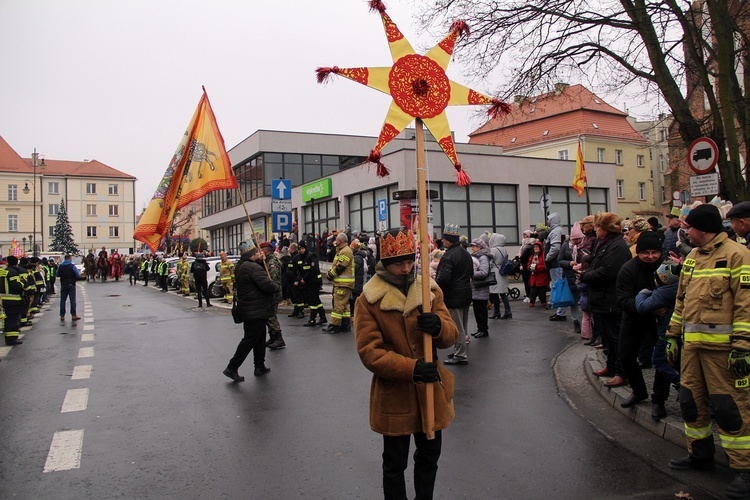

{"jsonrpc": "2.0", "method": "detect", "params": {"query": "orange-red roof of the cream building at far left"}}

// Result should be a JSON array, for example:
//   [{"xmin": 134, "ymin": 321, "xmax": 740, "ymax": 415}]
[{"xmin": 0, "ymin": 136, "xmax": 136, "ymax": 180}]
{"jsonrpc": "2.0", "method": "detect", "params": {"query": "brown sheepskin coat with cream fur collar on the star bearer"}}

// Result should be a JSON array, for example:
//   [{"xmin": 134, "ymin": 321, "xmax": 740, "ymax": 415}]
[{"xmin": 354, "ymin": 272, "xmax": 458, "ymax": 436}]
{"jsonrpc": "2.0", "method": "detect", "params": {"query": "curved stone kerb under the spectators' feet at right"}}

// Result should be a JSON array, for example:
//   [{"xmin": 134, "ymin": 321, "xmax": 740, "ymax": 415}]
[{"xmin": 583, "ymin": 352, "xmax": 729, "ymax": 467}]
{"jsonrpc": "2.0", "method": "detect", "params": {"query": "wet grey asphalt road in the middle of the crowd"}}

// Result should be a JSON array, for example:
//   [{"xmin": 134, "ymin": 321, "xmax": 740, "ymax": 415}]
[{"xmin": 0, "ymin": 282, "xmax": 728, "ymax": 499}]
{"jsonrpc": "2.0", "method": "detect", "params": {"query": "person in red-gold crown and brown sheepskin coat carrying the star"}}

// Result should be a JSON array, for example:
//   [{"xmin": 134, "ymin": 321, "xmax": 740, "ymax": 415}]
[{"xmin": 354, "ymin": 229, "xmax": 458, "ymax": 498}]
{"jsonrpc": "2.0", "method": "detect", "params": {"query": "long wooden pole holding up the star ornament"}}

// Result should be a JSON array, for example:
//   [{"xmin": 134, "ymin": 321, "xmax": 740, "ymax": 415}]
[{"xmin": 415, "ymin": 118, "xmax": 435, "ymax": 439}]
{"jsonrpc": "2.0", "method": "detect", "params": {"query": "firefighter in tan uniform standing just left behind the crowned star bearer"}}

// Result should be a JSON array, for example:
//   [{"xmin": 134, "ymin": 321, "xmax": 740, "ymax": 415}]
[{"xmin": 323, "ymin": 231, "xmax": 354, "ymax": 333}]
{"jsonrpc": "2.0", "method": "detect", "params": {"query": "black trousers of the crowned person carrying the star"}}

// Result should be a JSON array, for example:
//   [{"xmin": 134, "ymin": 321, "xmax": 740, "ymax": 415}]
[{"xmin": 383, "ymin": 431, "xmax": 443, "ymax": 500}]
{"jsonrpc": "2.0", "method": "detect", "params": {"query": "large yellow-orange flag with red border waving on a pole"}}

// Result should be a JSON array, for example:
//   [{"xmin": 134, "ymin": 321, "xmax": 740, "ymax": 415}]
[{"xmin": 133, "ymin": 88, "xmax": 238, "ymax": 252}]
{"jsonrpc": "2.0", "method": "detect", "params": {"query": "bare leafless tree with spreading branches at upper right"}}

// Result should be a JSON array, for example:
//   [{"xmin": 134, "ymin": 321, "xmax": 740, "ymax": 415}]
[{"xmin": 421, "ymin": 0, "xmax": 750, "ymax": 201}]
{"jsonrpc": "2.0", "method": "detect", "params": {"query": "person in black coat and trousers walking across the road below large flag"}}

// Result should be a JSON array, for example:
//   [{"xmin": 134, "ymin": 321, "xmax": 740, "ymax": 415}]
[{"xmin": 224, "ymin": 242, "xmax": 281, "ymax": 382}]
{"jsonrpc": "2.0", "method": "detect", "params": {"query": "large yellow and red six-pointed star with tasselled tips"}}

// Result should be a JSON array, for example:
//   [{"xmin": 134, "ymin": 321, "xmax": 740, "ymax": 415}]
[{"xmin": 316, "ymin": 0, "xmax": 510, "ymax": 186}]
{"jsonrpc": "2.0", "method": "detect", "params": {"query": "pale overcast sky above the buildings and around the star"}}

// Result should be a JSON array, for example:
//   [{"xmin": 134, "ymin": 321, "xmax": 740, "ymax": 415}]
[{"xmin": 0, "ymin": 0, "xmax": 640, "ymax": 213}]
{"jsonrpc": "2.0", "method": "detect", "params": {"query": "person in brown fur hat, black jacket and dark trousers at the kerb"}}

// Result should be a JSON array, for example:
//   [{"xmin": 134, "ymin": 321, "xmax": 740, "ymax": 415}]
[{"xmin": 580, "ymin": 212, "xmax": 632, "ymax": 387}]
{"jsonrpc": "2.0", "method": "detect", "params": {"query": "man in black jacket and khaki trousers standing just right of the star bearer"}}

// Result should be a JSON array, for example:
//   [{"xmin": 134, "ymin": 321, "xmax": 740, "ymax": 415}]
[{"xmin": 435, "ymin": 224, "xmax": 474, "ymax": 365}]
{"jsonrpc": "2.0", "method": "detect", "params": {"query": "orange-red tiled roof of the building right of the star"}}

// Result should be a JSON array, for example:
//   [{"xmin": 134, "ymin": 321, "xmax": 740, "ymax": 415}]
[{"xmin": 469, "ymin": 84, "xmax": 646, "ymax": 152}]
